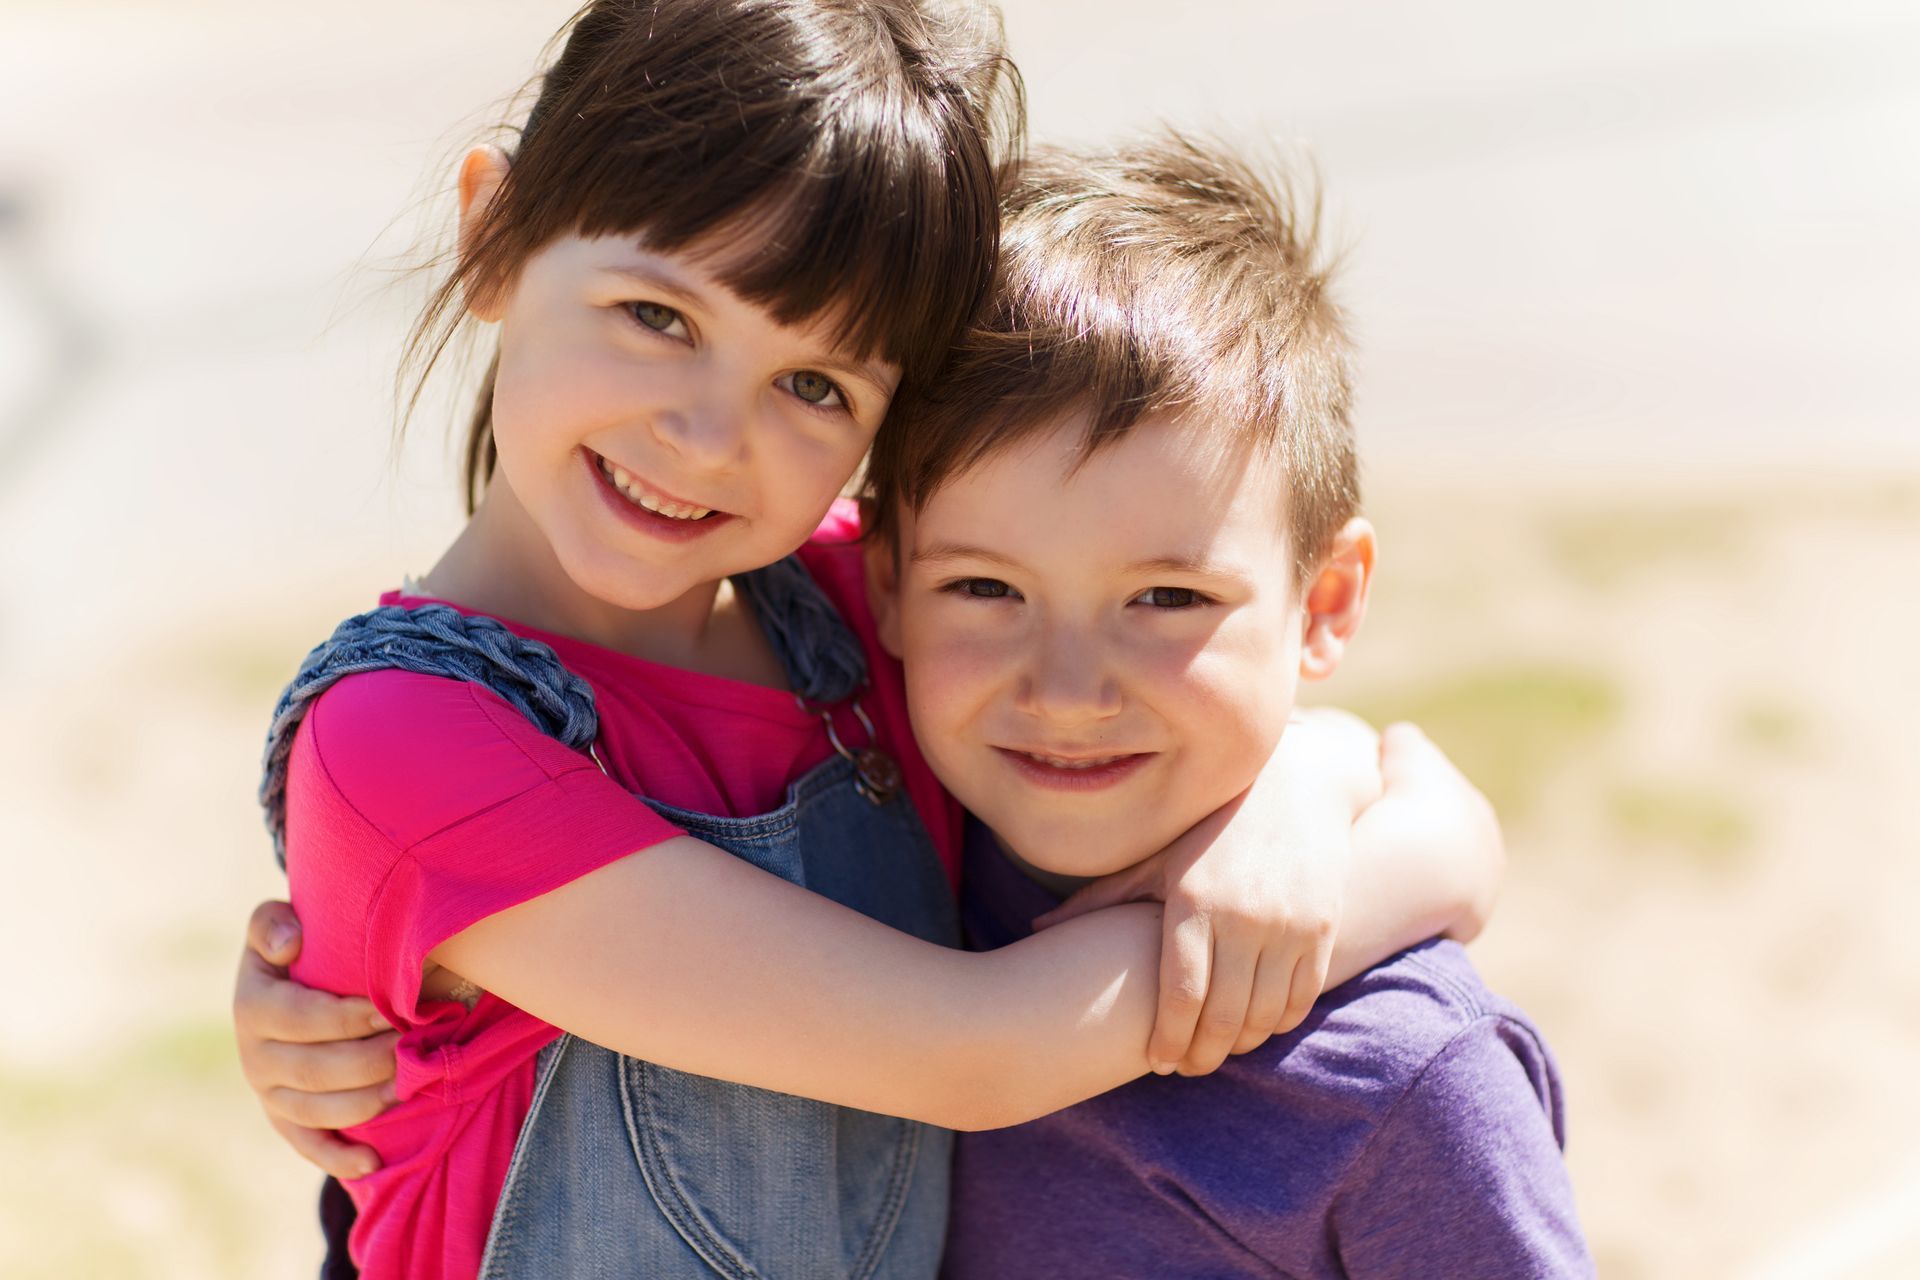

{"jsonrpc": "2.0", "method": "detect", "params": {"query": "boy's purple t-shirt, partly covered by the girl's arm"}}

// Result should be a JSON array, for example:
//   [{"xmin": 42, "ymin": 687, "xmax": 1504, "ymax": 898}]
[{"xmin": 943, "ymin": 823, "xmax": 1594, "ymax": 1280}]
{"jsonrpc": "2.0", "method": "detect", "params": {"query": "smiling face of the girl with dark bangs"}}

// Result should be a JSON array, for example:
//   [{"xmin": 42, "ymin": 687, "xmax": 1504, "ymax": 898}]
[{"xmin": 472, "ymin": 227, "xmax": 899, "ymax": 610}]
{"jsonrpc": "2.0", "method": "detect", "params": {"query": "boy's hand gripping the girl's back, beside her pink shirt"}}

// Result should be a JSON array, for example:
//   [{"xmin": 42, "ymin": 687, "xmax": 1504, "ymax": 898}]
[{"xmin": 234, "ymin": 902, "xmax": 399, "ymax": 1180}]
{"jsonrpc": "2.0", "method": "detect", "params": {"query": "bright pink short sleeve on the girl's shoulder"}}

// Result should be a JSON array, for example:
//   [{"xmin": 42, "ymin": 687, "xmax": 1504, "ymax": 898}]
[{"xmin": 288, "ymin": 672, "xmax": 682, "ymax": 1027}]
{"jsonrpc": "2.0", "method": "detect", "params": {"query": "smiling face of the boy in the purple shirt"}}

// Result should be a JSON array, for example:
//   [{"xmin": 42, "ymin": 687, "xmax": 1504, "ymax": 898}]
[{"xmin": 876, "ymin": 415, "xmax": 1304, "ymax": 875}]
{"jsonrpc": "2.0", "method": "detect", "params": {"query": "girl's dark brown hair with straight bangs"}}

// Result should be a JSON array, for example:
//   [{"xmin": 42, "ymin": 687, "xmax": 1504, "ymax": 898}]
[{"xmin": 405, "ymin": 0, "xmax": 1025, "ymax": 512}]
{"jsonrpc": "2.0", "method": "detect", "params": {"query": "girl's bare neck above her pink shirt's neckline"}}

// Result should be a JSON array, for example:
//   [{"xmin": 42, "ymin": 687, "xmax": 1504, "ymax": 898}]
[{"xmin": 420, "ymin": 482, "xmax": 785, "ymax": 687}]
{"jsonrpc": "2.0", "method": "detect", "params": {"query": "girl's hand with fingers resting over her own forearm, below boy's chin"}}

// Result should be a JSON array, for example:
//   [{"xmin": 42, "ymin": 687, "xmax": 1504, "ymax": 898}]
[{"xmin": 1035, "ymin": 710, "xmax": 1380, "ymax": 1075}]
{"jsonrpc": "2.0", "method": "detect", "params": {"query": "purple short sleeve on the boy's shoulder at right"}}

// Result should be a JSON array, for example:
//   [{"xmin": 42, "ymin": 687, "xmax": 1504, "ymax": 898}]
[{"xmin": 1332, "ymin": 1017, "xmax": 1594, "ymax": 1280}]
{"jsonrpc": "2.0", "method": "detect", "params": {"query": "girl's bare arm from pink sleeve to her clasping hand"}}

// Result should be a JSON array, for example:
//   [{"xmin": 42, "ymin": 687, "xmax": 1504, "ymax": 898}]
[{"xmin": 432, "ymin": 837, "xmax": 1160, "ymax": 1128}]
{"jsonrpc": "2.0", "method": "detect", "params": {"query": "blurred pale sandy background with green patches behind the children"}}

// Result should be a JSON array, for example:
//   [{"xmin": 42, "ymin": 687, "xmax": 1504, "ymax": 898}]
[{"xmin": 0, "ymin": 0, "xmax": 1920, "ymax": 1280}]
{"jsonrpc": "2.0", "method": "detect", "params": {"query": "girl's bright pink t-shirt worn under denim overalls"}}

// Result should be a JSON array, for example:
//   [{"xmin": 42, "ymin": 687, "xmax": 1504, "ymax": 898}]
[{"xmin": 286, "ymin": 503, "xmax": 960, "ymax": 1280}]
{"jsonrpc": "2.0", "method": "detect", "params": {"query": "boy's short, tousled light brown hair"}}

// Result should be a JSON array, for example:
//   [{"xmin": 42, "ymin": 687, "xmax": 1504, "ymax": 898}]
[{"xmin": 868, "ymin": 130, "xmax": 1359, "ymax": 581}]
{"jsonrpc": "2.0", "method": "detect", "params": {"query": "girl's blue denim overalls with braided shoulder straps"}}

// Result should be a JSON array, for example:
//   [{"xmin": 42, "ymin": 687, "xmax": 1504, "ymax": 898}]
[{"xmin": 261, "ymin": 558, "xmax": 960, "ymax": 1280}]
